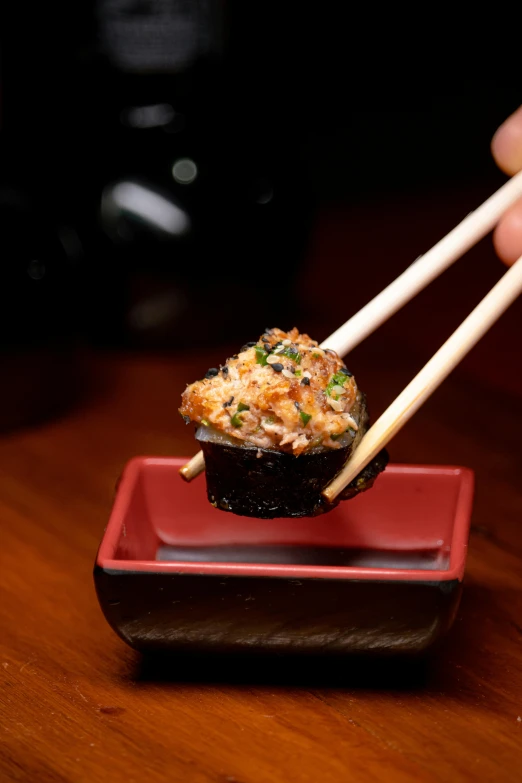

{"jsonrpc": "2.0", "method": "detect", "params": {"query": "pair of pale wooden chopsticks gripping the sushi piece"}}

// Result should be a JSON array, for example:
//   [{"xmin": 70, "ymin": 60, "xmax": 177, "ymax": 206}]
[{"xmin": 180, "ymin": 172, "xmax": 522, "ymax": 501}]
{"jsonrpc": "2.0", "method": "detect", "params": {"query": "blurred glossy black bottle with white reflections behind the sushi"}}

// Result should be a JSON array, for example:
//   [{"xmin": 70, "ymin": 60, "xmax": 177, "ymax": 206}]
[{"xmin": 6, "ymin": 0, "xmax": 312, "ymax": 348}]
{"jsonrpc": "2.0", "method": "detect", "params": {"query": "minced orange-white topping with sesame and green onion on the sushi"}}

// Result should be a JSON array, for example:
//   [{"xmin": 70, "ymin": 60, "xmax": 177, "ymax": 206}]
[{"xmin": 180, "ymin": 328, "xmax": 361, "ymax": 455}]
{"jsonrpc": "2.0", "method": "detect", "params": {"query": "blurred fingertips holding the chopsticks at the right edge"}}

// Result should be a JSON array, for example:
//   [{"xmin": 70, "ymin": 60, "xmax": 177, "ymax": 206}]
[{"xmin": 491, "ymin": 106, "xmax": 522, "ymax": 264}]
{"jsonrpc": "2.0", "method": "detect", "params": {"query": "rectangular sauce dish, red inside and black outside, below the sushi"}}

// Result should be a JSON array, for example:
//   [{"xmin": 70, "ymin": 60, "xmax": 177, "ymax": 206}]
[{"xmin": 94, "ymin": 457, "xmax": 474, "ymax": 654}]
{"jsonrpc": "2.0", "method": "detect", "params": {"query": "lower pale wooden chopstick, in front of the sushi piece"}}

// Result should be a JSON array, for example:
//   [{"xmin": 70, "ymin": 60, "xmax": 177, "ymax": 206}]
[{"xmin": 322, "ymin": 256, "xmax": 522, "ymax": 501}]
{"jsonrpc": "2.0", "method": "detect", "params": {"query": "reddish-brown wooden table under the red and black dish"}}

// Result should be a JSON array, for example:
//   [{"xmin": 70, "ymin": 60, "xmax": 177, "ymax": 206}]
[{"xmin": 0, "ymin": 185, "xmax": 522, "ymax": 783}]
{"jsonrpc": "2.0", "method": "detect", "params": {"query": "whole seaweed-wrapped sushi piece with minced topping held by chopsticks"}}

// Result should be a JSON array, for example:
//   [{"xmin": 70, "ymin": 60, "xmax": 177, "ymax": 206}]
[{"xmin": 179, "ymin": 328, "xmax": 388, "ymax": 519}]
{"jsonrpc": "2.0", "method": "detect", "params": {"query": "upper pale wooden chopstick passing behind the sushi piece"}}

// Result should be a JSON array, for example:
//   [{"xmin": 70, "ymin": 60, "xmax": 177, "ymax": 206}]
[{"xmin": 179, "ymin": 171, "xmax": 522, "ymax": 481}]
